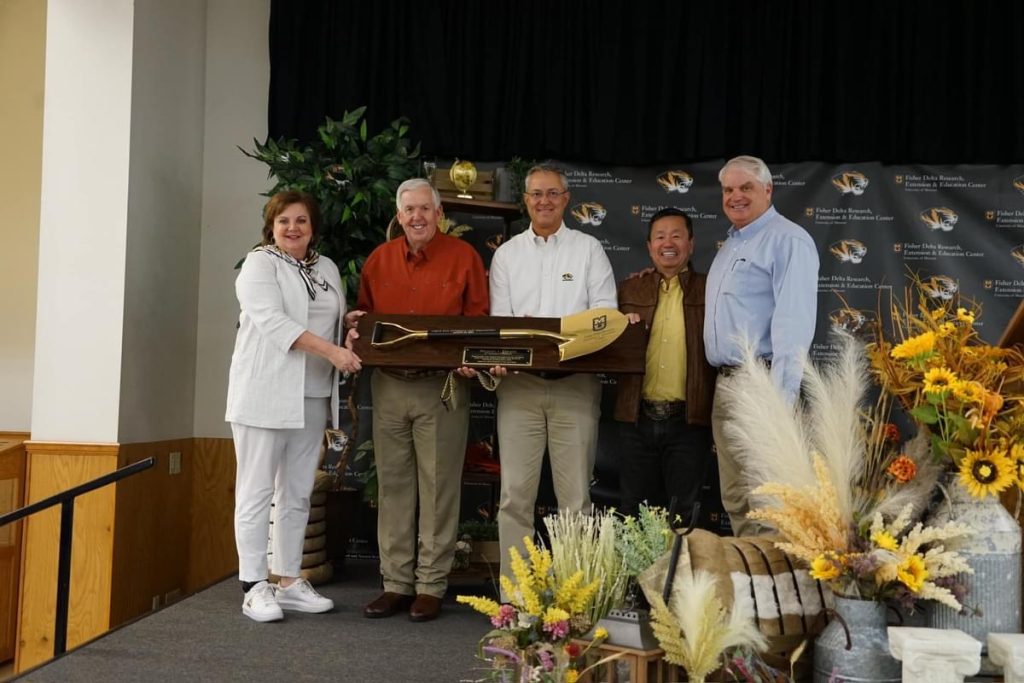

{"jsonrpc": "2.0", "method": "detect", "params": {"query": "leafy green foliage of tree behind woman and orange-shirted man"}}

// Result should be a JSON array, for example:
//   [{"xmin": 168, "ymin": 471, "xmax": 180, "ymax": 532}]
[{"xmin": 239, "ymin": 106, "xmax": 420, "ymax": 302}]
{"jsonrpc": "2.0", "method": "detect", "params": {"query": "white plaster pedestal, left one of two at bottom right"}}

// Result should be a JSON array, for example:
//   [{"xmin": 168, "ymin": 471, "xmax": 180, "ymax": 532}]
[{"xmin": 889, "ymin": 626, "xmax": 981, "ymax": 683}]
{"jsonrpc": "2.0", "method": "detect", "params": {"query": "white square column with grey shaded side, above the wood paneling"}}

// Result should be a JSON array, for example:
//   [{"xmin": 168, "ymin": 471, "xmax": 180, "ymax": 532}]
[{"xmin": 32, "ymin": 0, "xmax": 207, "ymax": 443}]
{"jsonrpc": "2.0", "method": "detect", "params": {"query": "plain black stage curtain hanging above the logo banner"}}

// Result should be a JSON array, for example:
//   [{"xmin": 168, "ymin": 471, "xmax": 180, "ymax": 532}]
[{"xmin": 269, "ymin": 0, "xmax": 1024, "ymax": 166}]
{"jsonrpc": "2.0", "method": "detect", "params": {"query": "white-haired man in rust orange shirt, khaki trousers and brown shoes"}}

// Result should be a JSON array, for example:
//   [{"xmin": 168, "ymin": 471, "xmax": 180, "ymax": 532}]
[{"xmin": 356, "ymin": 178, "xmax": 489, "ymax": 622}]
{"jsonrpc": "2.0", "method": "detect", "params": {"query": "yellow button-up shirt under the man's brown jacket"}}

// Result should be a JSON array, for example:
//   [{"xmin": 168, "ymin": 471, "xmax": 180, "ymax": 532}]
[{"xmin": 643, "ymin": 278, "xmax": 686, "ymax": 400}]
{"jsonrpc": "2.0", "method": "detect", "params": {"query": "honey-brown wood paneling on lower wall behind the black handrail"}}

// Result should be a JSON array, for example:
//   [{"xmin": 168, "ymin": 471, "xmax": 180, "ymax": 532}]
[{"xmin": 14, "ymin": 438, "xmax": 238, "ymax": 671}]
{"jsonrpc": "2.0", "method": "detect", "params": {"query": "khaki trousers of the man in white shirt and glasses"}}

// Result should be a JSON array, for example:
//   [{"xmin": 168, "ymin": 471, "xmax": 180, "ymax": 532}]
[{"xmin": 498, "ymin": 373, "xmax": 601, "ymax": 578}]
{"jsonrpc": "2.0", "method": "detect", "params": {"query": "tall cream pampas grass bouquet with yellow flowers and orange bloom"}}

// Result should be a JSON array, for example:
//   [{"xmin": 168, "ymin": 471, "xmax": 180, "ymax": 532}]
[{"xmin": 720, "ymin": 335, "xmax": 970, "ymax": 609}]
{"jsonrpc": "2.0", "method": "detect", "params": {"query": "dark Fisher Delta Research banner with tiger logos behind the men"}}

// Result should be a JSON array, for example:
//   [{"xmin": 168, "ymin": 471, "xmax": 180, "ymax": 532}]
[{"xmin": 524, "ymin": 161, "xmax": 1024, "ymax": 359}]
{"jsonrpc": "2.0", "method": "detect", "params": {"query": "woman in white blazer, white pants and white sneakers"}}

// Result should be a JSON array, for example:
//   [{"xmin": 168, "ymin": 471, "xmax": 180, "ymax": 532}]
[{"xmin": 225, "ymin": 191, "xmax": 360, "ymax": 622}]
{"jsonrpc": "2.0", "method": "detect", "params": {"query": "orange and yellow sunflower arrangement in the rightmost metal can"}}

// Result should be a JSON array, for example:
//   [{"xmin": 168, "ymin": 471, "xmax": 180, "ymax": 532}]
[{"xmin": 867, "ymin": 281, "xmax": 1024, "ymax": 499}]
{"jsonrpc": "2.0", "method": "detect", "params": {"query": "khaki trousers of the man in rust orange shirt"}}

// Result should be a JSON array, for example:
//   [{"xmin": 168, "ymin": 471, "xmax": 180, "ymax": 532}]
[{"xmin": 371, "ymin": 371, "xmax": 469, "ymax": 598}]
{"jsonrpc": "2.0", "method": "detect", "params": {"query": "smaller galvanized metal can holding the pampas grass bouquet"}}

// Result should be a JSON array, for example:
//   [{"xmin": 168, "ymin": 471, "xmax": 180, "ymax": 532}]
[{"xmin": 814, "ymin": 595, "xmax": 902, "ymax": 683}]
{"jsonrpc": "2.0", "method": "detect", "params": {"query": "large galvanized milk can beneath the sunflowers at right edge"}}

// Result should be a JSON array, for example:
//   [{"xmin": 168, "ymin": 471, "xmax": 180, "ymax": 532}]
[{"xmin": 925, "ymin": 480, "xmax": 1021, "ymax": 673}]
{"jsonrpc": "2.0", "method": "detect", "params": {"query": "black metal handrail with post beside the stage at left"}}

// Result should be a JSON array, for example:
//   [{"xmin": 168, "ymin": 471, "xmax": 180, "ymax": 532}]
[{"xmin": 0, "ymin": 458, "xmax": 157, "ymax": 656}]
